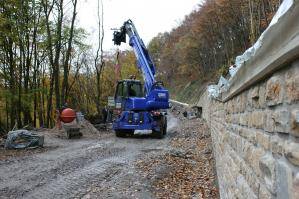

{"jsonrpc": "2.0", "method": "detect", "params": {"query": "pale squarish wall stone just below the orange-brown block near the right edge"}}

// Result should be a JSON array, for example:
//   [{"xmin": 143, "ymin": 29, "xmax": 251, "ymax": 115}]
[{"xmin": 272, "ymin": 109, "xmax": 290, "ymax": 133}]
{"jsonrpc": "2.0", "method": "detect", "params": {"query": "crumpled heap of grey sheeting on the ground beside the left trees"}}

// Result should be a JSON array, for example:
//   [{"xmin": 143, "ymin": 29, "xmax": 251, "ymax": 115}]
[{"xmin": 5, "ymin": 130, "xmax": 44, "ymax": 149}]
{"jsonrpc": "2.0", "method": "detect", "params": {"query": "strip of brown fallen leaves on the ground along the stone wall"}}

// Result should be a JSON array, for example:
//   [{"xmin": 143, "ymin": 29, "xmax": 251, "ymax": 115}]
[{"xmin": 136, "ymin": 119, "xmax": 219, "ymax": 198}]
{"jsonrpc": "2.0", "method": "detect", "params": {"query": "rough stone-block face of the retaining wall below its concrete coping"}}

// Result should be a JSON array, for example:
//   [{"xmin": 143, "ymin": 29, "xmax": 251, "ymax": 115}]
[{"xmin": 198, "ymin": 60, "xmax": 299, "ymax": 198}]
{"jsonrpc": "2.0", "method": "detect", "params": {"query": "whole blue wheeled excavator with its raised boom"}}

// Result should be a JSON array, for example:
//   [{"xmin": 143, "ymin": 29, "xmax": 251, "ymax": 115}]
[{"xmin": 113, "ymin": 20, "xmax": 170, "ymax": 138}]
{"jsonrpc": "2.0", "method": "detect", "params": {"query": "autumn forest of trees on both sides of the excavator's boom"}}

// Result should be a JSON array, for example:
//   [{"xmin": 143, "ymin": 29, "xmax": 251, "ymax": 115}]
[{"xmin": 0, "ymin": 0, "xmax": 281, "ymax": 132}]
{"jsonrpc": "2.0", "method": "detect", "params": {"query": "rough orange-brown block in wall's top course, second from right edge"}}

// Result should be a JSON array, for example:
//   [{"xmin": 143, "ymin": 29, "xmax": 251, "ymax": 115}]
[{"xmin": 266, "ymin": 75, "xmax": 284, "ymax": 106}]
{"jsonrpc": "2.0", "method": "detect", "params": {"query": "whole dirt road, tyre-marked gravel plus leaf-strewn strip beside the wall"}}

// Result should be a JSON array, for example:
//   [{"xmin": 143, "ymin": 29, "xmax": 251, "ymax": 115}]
[{"xmin": 0, "ymin": 112, "xmax": 218, "ymax": 198}]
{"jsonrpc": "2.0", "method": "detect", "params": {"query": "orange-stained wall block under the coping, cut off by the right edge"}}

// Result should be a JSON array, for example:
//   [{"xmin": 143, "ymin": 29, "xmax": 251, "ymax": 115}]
[{"xmin": 285, "ymin": 62, "xmax": 299, "ymax": 103}]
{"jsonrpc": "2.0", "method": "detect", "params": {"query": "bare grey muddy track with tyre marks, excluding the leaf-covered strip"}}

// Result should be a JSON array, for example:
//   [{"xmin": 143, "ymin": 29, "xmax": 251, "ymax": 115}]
[{"xmin": 0, "ymin": 112, "xmax": 218, "ymax": 198}]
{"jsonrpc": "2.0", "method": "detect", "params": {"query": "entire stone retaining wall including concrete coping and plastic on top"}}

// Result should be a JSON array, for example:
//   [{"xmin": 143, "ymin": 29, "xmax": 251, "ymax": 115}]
[{"xmin": 197, "ymin": 0, "xmax": 299, "ymax": 199}]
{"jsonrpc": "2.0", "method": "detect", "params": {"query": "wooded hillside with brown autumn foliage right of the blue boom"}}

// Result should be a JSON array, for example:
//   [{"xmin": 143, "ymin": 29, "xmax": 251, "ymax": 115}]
[{"xmin": 149, "ymin": 0, "xmax": 281, "ymax": 100}]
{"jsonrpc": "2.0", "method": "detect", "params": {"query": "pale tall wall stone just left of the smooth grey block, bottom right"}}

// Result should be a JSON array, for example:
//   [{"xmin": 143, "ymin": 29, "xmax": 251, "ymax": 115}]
[{"xmin": 259, "ymin": 154, "xmax": 276, "ymax": 194}]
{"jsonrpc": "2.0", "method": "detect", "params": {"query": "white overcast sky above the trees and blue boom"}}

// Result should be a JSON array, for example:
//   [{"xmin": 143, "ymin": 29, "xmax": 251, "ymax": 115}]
[{"xmin": 77, "ymin": 0, "xmax": 201, "ymax": 51}]
